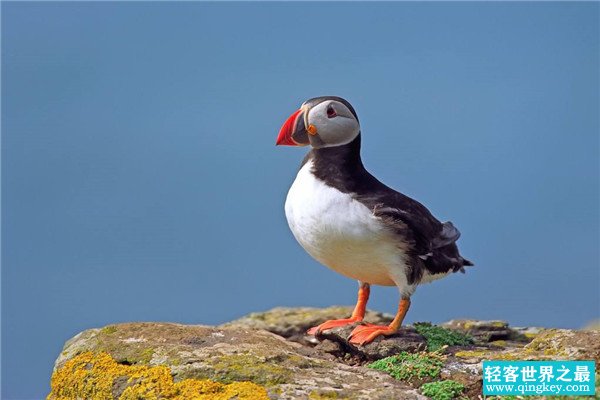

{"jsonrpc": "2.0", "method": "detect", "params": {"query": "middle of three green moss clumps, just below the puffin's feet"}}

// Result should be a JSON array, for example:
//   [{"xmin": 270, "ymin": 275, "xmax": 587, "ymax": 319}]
[{"xmin": 367, "ymin": 351, "xmax": 444, "ymax": 383}]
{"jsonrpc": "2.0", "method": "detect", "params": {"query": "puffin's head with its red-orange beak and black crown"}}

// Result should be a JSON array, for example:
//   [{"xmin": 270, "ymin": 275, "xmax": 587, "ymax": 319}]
[{"xmin": 276, "ymin": 96, "xmax": 360, "ymax": 149}]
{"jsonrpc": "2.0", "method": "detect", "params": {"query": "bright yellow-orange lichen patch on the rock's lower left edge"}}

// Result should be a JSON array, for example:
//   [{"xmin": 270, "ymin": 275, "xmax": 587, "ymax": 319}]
[{"xmin": 47, "ymin": 352, "xmax": 268, "ymax": 400}]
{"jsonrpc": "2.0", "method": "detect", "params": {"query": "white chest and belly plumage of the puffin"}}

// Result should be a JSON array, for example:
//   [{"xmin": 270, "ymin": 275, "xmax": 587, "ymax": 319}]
[{"xmin": 285, "ymin": 161, "xmax": 404, "ymax": 285}]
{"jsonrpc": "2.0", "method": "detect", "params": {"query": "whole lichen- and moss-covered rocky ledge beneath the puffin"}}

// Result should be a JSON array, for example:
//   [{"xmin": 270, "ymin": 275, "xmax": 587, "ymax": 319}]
[{"xmin": 48, "ymin": 307, "xmax": 600, "ymax": 400}]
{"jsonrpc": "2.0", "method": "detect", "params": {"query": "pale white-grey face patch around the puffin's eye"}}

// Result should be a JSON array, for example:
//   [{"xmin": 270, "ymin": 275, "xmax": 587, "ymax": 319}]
[{"xmin": 307, "ymin": 100, "xmax": 360, "ymax": 148}]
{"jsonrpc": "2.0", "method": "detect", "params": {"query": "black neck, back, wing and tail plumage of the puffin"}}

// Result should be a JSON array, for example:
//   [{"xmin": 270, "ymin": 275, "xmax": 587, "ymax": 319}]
[{"xmin": 302, "ymin": 134, "xmax": 473, "ymax": 284}]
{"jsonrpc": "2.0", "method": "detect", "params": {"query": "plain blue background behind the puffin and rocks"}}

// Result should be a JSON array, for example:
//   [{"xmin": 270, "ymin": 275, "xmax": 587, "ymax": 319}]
[{"xmin": 2, "ymin": 2, "xmax": 600, "ymax": 399}]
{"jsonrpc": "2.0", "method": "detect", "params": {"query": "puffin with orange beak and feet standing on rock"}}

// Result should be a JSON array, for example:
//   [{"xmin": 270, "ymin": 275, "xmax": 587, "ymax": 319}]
[{"xmin": 276, "ymin": 96, "xmax": 473, "ymax": 345}]
